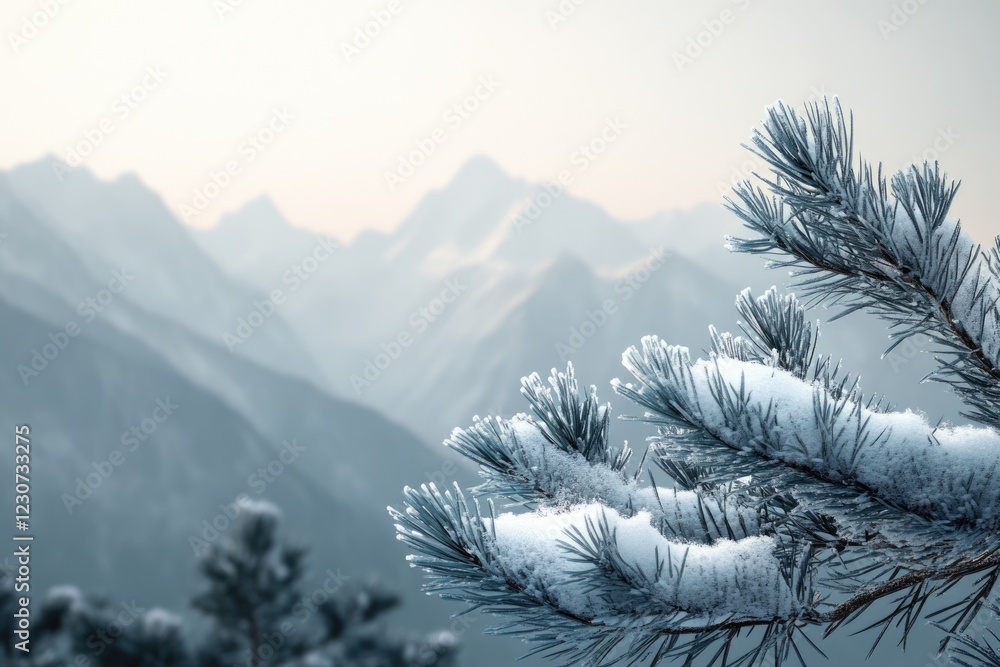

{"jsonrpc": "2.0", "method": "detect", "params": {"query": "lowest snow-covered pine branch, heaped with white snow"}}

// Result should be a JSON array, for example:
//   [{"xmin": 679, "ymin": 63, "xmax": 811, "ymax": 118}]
[{"xmin": 391, "ymin": 484, "xmax": 812, "ymax": 664}]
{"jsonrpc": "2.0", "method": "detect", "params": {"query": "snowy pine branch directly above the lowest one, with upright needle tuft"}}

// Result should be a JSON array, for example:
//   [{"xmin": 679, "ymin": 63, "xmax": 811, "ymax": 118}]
[{"xmin": 445, "ymin": 366, "xmax": 758, "ymax": 543}]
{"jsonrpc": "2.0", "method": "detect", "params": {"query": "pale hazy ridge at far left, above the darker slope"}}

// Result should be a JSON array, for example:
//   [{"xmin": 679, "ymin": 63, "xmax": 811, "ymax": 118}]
[{"xmin": 0, "ymin": 158, "xmax": 323, "ymax": 382}]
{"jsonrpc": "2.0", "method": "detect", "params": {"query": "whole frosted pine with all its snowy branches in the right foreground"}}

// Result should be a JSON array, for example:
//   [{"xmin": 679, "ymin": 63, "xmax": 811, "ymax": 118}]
[{"xmin": 390, "ymin": 100, "xmax": 1000, "ymax": 665}]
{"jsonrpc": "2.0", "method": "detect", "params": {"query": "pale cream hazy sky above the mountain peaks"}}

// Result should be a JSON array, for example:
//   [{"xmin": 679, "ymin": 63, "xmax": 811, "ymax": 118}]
[{"xmin": 0, "ymin": 0, "xmax": 1000, "ymax": 241}]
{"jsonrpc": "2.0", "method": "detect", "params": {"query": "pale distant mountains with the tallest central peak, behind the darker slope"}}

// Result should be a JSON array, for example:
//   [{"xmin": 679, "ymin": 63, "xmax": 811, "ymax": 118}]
[{"xmin": 195, "ymin": 157, "xmax": 958, "ymax": 443}]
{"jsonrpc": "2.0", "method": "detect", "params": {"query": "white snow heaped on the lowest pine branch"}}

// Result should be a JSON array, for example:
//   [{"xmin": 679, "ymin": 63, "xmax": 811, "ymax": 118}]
[{"xmin": 492, "ymin": 503, "xmax": 796, "ymax": 618}]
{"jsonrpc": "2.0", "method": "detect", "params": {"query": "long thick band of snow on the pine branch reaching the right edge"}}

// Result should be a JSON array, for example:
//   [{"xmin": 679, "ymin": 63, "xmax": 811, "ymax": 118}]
[{"xmin": 619, "ymin": 336, "xmax": 1000, "ymax": 530}]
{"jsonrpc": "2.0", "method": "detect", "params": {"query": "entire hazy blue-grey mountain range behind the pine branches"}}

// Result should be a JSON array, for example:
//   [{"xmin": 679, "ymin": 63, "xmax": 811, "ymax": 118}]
[{"xmin": 0, "ymin": 157, "xmax": 957, "ymax": 665}]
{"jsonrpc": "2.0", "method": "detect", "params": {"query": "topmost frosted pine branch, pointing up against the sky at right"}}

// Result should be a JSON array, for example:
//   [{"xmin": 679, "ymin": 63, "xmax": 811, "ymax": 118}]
[{"xmin": 726, "ymin": 99, "xmax": 1000, "ymax": 426}]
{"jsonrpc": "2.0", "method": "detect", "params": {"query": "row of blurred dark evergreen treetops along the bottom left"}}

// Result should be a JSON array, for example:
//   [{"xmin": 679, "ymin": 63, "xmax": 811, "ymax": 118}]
[{"xmin": 0, "ymin": 503, "xmax": 458, "ymax": 667}]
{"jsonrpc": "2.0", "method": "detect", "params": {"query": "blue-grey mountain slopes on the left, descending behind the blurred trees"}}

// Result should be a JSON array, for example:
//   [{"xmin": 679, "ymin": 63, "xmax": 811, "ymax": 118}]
[{"xmin": 0, "ymin": 159, "xmax": 523, "ymax": 664}]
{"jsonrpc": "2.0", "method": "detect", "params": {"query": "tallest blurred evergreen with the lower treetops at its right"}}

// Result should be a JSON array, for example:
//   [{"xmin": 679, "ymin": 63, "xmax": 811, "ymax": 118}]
[{"xmin": 193, "ymin": 503, "xmax": 457, "ymax": 667}]
